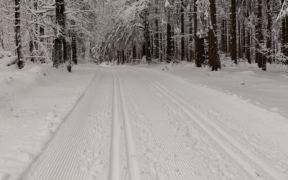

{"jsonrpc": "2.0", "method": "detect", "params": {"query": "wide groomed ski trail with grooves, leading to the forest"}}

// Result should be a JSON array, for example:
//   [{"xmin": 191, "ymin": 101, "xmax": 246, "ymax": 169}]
[{"xmin": 21, "ymin": 67, "xmax": 288, "ymax": 180}]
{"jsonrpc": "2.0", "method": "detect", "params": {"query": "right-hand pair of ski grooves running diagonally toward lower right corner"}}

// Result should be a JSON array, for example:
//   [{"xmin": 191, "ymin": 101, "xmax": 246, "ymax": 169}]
[{"xmin": 138, "ymin": 70, "xmax": 285, "ymax": 180}]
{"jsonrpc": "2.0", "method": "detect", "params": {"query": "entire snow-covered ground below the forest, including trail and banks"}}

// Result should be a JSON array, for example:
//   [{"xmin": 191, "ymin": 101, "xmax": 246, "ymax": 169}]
[{"xmin": 0, "ymin": 59, "xmax": 288, "ymax": 180}]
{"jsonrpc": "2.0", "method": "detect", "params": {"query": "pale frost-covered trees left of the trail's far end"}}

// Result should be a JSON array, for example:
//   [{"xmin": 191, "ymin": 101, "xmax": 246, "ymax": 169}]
[{"xmin": 0, "ymin": 0, "xmax": 99, "ymax": 71}]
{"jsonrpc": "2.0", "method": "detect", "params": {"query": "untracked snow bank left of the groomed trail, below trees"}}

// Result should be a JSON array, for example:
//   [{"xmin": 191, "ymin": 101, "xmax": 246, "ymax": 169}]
[{"xmin": 0, "ymin": 61, "xmax": 95, "ymax": 180}]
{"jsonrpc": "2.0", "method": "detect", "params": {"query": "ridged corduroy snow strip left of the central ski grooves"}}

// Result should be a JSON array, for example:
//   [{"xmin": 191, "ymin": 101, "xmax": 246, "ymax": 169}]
[{"xmin": 21, "ymin": 70, "xmax": 112, "ymax": 180}]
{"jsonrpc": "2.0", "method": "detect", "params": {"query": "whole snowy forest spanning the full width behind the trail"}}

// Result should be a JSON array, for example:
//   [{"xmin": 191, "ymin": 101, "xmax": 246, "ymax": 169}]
[{"xmin": 0, "ymin": 0, "xmax": 288, "ymax": 71}]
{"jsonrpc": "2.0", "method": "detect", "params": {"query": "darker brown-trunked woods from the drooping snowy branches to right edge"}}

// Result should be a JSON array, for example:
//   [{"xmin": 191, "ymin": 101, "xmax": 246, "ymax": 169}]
[{"xmin": 96, "ymin": 0, "xmax": 288, "ymax": 71}]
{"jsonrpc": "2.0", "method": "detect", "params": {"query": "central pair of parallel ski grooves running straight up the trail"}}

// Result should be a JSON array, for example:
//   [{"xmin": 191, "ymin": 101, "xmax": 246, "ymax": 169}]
[{"xmin": 109, "ymin": 71, "xmax": 140, "ymax": 180}]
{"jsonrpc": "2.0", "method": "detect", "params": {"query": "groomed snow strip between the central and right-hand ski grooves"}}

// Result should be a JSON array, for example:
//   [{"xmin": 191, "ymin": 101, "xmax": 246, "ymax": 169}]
[{"xmin": 118, "ymin": 69, "xmax": 251, "ymax": 180}]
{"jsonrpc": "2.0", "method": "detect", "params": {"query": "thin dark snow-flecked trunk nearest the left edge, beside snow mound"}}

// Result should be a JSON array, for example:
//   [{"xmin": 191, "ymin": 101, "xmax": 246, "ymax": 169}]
[{"xmin": 15, "ymin": 0, "xmax": 25, "ymax": 69}]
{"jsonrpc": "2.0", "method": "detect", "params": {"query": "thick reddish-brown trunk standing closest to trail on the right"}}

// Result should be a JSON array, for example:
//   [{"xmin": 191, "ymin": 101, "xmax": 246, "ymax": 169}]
[{"xmin": 208, "ymin": 0, "xmax": 221, "ymax": 71}]
